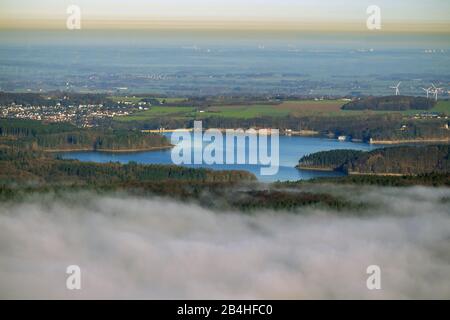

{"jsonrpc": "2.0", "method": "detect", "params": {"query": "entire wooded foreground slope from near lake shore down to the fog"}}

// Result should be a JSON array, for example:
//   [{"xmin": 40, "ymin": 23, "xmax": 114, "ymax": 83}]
[{"xmin": 0, "ymin": 147, "xmax": 360, "ymax": 212}]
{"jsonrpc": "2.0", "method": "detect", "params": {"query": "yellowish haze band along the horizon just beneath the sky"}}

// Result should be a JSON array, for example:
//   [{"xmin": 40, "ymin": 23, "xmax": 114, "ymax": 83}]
[{"xmin": 0, "ymin": 19, "xmax": 450, "ymax": 34}]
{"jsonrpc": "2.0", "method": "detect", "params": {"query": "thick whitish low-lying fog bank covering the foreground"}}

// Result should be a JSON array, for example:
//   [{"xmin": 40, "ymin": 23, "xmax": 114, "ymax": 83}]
[{"xmin": 0, "ymin": 188, "xmax": 450, "ymax": 299}]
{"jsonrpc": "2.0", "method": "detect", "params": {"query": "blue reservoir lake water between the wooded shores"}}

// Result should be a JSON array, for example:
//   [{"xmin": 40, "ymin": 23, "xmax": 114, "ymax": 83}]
[{"xmin": 61, "ymin": 136, "xmax": 384, "ymax": 182}]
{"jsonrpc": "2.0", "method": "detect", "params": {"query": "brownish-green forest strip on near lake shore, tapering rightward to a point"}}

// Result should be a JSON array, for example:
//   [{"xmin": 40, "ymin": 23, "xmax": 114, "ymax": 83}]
[{"xmin": 0, "ymin": 146, "xmax": 255, "ymax": 185}]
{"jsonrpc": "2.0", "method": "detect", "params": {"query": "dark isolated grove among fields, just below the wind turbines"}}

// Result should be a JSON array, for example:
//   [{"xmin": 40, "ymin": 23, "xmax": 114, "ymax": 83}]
[{"xmin": 342, "ymin": 96, "xmax": 436, "ymax": 111}]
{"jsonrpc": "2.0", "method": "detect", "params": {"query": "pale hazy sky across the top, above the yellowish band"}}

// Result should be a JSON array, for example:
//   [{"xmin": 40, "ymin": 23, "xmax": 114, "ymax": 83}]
[{"xmin": 0, "ymin": 0, "xmax": 450, "ymax": 29}]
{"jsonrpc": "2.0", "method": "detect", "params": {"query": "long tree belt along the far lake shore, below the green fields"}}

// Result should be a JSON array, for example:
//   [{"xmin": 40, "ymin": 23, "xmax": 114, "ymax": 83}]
[{"xmin": 109, "ymin": 113, "xmax": 450, "ymax": 142}]
